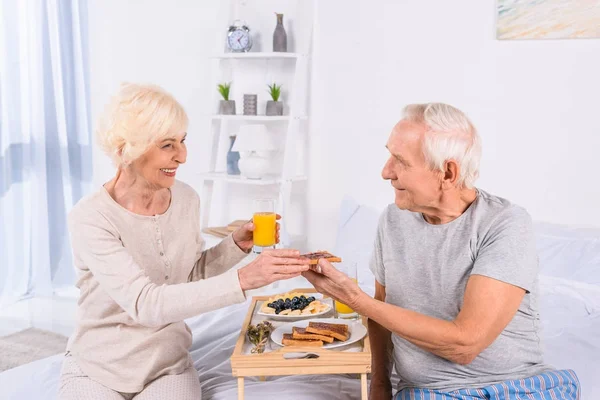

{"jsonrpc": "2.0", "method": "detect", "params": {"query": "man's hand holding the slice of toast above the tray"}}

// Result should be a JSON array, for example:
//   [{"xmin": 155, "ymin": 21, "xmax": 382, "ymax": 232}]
[{"xmin": 302, "ymin": 259, "xmax": 367, "ymax": 310}]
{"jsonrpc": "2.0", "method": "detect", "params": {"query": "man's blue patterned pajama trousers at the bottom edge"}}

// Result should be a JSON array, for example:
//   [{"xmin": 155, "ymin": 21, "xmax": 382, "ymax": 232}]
[{"xmin": 395, "ymin": 369, "xmax": 581, "ymax": 400}]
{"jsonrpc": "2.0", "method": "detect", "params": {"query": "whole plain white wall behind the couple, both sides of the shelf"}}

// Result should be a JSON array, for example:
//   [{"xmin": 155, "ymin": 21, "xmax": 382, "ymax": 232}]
[{"xmin": 90, "ymin": 0, "xmax": 600, "ymax": 253}]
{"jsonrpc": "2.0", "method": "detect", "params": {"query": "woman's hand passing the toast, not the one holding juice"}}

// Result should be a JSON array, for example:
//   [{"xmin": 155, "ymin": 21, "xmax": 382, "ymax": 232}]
[{"xmin": 238, "ymin": 249, "xmax": 310, "ymax": 290}]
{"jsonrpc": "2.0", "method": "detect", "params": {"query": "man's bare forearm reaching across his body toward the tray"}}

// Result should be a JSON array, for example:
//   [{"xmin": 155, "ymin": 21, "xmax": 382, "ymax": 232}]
[{"xmin": 354, "ymin": 295, "xmax": 473, "ymax": 364}]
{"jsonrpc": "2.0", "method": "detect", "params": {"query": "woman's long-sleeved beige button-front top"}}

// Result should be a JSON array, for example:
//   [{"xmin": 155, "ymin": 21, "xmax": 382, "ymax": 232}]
[{"xmin": 67, "ymin": 181, "xmax": 246, "ymax": 393}]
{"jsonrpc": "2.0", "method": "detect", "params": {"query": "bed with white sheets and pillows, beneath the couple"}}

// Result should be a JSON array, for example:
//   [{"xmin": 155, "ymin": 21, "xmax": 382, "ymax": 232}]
[{"xmin": 0, "ymin": 198, "xmax": 600, "ymax": 400}]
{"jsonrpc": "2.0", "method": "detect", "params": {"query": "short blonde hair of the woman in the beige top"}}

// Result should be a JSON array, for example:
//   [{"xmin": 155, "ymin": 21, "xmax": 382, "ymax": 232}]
[{"xmin": 96, "ymin": 83, "xmax": 188, "ymax": 166}]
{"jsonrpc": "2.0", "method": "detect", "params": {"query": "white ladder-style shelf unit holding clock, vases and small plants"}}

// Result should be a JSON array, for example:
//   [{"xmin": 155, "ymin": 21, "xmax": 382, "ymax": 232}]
[{"xmin": 198, "ymin": 0, "xmax": 316, "ymax": 247}]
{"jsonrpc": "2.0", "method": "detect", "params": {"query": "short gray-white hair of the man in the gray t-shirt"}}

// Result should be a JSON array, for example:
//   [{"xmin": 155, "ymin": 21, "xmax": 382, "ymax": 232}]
[{"xmin": 403, "ymin": 103, "xmax": 481, "ymax": 189}]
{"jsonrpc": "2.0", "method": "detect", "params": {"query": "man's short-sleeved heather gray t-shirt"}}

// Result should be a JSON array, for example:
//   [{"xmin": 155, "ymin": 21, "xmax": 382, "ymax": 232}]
[{"xmin": 371, "ymin": 189, "xmax": 548, "ymax": 390}]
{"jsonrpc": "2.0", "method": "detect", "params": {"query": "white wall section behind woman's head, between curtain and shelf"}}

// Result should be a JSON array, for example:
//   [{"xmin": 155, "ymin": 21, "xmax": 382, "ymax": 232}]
[{"xmin": 89, "ymin": 0, "xmax": 218, "ymax": 186}]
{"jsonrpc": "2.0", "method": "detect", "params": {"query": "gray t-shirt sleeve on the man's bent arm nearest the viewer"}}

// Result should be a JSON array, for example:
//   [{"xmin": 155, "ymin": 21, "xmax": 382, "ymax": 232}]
[{"xmin": 471, "ymin": 206, "xmax": 539, "ymax": 292}]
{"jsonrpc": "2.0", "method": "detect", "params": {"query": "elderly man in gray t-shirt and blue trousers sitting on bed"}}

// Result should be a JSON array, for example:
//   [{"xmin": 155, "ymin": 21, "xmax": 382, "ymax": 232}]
[{"xmin": 304, "ymin": 104, "xmax": 580, "ymax": 400}]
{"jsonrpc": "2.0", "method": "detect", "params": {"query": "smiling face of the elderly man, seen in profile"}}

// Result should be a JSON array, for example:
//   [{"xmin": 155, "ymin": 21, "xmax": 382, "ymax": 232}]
[{"xmin": 381, "ymin": 120, "xmax": 443, "ymax": 211}]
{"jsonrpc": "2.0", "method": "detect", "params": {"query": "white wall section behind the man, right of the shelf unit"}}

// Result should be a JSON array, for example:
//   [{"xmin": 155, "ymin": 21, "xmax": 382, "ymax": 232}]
[{"xmin": 309, "ymin": 0, "xmax": 600, "ymax": 247}]
